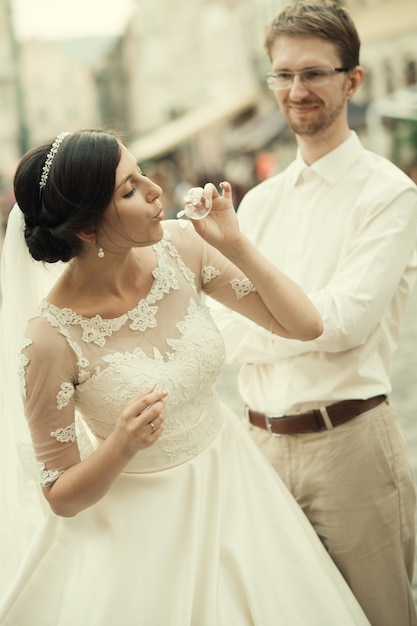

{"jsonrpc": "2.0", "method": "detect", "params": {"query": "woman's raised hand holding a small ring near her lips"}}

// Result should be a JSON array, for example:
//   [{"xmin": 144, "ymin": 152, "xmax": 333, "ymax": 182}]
[{"xmin": 188, "ymin": 182, "xmax": 241, "ymax": 251}]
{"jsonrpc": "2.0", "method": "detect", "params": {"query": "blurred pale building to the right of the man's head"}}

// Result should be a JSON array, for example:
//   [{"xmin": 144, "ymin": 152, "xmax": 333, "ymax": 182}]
[{"xmin": 346, "ymin": 0, "xmax": 417, "ymax": 176}]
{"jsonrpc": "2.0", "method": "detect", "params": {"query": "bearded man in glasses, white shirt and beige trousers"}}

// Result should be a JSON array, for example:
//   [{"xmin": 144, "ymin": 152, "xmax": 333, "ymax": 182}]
[{"xmin": 214, "ymin": 0, "xmax": 417, "ymax": 626}]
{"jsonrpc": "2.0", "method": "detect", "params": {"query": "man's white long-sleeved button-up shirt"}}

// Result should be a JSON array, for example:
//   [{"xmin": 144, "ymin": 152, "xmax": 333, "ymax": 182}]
[{"xmin": 212, "ymin": 132, "xmax": 417, "ymax": 415}]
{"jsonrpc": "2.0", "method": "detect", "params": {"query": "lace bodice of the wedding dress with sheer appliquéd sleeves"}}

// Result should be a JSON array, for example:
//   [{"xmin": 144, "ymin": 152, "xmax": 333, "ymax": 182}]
[{"xmin": 21, "ymin": 222, "xmax": 266, "ymax": 484}]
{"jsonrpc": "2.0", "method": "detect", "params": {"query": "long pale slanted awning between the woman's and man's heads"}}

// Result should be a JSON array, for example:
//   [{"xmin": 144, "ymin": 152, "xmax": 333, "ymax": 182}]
[{"xmin": 129, "ymin": 90, "xmax": 258, "ymax": 161}]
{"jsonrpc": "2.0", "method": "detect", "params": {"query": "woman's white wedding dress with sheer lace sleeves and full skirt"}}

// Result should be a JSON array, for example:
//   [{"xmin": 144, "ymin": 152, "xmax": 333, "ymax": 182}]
[{"xmin": 0, "ymin": 222, "xmax": 368, "ymax": 626}]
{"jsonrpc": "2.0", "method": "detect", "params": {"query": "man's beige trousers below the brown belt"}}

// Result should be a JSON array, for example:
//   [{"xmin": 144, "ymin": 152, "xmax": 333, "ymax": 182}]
[{"xmin": 249, "ymin": 402, "xmax": 417, "ymax": 626}]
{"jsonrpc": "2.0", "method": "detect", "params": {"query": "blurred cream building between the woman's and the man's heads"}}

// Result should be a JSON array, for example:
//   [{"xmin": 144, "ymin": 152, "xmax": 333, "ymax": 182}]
[{"xmin": 105, "ymin": 0, "xmax": 258, "ymax": 179}]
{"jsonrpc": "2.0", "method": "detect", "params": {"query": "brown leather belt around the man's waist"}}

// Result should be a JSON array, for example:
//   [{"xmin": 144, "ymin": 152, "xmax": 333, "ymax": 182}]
[{"xmin": 247, "ymin": 396, "xmax": 386, "ymax": 435}]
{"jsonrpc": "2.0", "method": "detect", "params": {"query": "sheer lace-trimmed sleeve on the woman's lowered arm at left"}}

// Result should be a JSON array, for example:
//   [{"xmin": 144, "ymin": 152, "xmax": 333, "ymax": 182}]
[{"xmin": 20, "ymin": 318, "xmax": 80, "ymax": 486}]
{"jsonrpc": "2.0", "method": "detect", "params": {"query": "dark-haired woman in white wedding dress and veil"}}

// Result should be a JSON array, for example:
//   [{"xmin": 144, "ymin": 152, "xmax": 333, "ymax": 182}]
[{"xmin": 0, "ymin": 130, "xmax": 368, "ymax": 626}]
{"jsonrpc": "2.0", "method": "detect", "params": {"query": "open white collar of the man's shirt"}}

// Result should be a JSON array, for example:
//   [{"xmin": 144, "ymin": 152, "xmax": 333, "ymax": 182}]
[{"xmin": 293, "ymin": 131, "xmax": 363, "ymax": 187}]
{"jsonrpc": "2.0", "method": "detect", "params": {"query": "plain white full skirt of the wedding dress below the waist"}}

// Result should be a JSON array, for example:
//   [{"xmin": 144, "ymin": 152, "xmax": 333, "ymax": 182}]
[{"xmin": 0, "ymin": 405, "xmax": 369, "ymax": 626}]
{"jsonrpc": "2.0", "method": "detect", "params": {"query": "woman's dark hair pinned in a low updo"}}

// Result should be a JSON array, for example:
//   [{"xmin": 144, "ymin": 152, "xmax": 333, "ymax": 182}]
[{"xmin": 14, "ymin": 130, "xmax": 123, "ymax": 263}]
